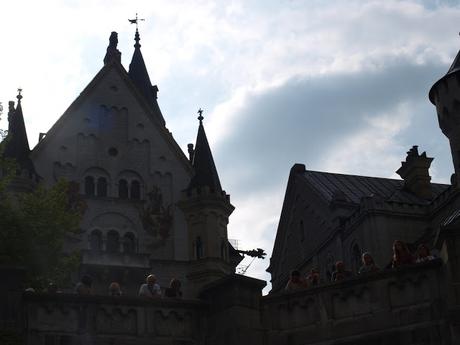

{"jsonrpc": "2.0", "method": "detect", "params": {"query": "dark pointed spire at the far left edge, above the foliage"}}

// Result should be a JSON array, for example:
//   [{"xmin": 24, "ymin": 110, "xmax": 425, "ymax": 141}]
[{"xmin": 3, "ymin": 89, "xmax": 38, "ymax": 178}]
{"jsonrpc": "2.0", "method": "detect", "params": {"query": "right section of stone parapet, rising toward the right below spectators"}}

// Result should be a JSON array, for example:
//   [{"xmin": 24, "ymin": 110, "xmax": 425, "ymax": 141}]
[{"xmin": 261, "ymin": 260, "xmax": 448, "ymax": 344}]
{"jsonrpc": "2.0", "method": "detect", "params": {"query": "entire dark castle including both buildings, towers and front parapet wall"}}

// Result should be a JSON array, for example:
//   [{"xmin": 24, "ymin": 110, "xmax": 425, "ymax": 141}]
[{"xmin": 0, "ymin": 31, "xmax": 460, "ymax": 345}]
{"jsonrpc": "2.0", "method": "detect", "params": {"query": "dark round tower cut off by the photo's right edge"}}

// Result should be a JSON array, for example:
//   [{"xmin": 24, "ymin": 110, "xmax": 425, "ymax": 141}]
[{"xmin": 429, "ymin": 42, "xmax": 460, "ymax": 184}]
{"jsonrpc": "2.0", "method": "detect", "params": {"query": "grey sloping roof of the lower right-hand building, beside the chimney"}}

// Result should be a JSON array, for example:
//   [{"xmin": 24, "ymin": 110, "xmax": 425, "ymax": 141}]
[{"xmin": 303, "ymin": 170, "xmax": 449, "ymax": 205}]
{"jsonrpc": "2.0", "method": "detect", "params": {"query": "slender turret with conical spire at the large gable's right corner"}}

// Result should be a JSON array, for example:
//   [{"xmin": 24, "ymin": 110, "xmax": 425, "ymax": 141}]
[{"xmin": 179, "ymin": 109, "xmax": 235, "ymax": 291}]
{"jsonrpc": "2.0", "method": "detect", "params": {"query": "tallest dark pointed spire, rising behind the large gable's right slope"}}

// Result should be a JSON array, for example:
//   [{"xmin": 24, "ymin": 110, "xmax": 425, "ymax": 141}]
[{"xmin": 128, "ymin": 29, "xmax": 165, "ymax": 125}]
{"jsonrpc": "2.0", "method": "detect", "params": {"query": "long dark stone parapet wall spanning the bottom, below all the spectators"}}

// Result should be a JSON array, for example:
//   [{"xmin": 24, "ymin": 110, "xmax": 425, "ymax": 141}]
[{"xmin": 4, "ymin": 259, "xmax": 460, "ymax": 345}]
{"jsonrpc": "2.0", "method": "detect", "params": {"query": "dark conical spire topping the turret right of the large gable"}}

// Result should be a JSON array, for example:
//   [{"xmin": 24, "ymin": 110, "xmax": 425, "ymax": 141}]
[{"xmin": 188, "ymin": 108, "xmax": 222, "ymax": 193}]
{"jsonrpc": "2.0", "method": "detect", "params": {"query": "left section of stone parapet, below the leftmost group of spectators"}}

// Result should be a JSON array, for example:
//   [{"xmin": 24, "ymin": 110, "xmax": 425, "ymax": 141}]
[{"xmin": 23, "ymin": 293, "xmax": 207, "ymax": 345}]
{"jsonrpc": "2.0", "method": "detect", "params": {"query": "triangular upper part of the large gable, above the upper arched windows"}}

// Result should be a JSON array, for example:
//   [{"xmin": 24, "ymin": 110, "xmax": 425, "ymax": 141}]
[{"xmin": 32, "ymin": 61, "xmax": 192, "ymax": 188}]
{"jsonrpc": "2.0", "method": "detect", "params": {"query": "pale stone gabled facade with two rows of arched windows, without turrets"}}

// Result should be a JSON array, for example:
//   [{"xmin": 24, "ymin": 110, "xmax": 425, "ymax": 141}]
[{"xmin": 31, "ymin": 59, "xmax": 193, "ymax": 266}]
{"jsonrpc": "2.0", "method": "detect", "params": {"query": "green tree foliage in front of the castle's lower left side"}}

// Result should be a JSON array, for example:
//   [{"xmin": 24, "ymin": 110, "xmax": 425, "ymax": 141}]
[{"xmin": 0, "ymin": 173, "xmax": 84, "ymax": 289}]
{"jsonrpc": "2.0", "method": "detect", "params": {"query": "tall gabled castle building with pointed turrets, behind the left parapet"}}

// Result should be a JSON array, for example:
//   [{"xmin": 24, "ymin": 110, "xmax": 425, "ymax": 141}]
[{"xmin": 0, "ymin": 29, "xmax": 241, "ymax": 297}]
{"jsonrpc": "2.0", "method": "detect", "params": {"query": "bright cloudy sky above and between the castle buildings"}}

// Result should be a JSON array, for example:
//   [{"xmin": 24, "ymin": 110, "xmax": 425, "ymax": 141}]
[{"xmin": 0, "ymin": 0, "xmax": 460, "ymax": 292}]
